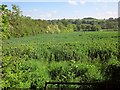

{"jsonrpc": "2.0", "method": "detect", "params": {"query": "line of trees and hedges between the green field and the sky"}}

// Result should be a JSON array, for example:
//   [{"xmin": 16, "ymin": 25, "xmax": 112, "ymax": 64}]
[{"xmin": 0, "ymin": 5, "xmax": 118, "ymax": 38}]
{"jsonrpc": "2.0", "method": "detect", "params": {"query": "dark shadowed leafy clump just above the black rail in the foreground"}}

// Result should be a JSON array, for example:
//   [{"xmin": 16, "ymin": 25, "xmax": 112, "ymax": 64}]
[{"xmin": 49, "ymin": 60, "xmax": 103, "ymax": 82}]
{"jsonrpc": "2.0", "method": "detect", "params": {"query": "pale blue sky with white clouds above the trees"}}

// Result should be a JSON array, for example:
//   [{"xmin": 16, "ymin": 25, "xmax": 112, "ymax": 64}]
[{"xmin": 2, "ymin": 0, "xmax": 119, "ymax": 20}]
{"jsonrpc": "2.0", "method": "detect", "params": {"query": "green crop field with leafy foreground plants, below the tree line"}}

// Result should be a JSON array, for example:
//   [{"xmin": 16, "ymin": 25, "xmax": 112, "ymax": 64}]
[{"xmin": 2, "ymin": 31, "xmax": 120, "ymax": 88}]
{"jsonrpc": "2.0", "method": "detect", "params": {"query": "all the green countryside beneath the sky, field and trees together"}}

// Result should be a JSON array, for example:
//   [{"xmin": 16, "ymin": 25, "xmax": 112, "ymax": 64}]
[{"xmin": 0, "ymin": 4, "xmax": 120, "ymax": 90}]
